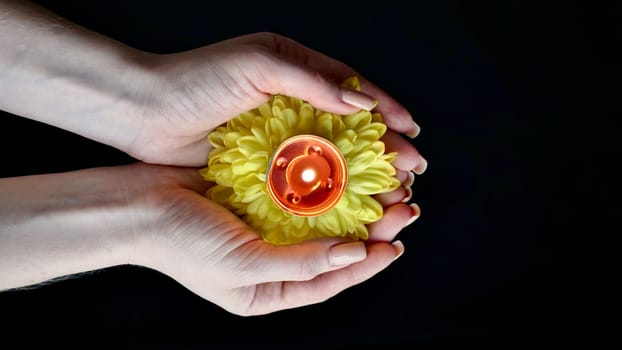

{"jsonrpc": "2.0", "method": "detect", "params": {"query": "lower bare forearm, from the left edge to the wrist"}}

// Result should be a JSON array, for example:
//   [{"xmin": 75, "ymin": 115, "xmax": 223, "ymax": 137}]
[{"xmin": 0, "ymin": 168, "xmax": 134, "ymax": 290}]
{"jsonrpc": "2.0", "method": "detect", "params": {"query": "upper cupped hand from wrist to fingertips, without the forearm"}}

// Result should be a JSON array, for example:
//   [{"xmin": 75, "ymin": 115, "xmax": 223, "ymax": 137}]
[{"xmin": 126, "ymin": 33, "xmax": 426, "ymax": 172}]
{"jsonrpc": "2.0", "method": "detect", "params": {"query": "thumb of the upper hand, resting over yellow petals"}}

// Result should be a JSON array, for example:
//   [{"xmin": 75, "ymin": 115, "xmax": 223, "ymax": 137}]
[{"xmin": 250, "ymin": 54, "xmax": 378, "ymax": 115}]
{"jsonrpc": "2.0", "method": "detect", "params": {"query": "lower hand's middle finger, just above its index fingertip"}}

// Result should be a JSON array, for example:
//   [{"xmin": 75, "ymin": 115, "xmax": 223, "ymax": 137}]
[{"xmin": 367, "ymin": 203, "xmax": 421, "ymax": 241}]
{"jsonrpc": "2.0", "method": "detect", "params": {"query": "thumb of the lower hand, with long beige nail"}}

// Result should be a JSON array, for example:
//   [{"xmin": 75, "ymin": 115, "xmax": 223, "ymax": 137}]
[{"xmin": 256, "ymin": 239, "xmax": 367, "ymax": 282}]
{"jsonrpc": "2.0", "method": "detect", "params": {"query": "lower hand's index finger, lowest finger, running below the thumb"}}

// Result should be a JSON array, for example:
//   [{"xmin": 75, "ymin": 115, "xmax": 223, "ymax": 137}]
[{"xmin": 249, "ymin": 242, "xmax": 404, "ymax": 314}]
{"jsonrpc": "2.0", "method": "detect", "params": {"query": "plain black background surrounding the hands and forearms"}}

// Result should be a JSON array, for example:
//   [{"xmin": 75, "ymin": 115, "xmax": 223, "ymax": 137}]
[{"xmin": 0, "ymin": 0, "xmax": 622, "ymax": 349}]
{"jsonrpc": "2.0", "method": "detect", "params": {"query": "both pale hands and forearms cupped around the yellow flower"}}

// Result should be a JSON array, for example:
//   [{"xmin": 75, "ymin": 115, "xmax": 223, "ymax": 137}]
[{"xmin": 0, "ymin": 1, "xmax": 427, "ymax": 315}]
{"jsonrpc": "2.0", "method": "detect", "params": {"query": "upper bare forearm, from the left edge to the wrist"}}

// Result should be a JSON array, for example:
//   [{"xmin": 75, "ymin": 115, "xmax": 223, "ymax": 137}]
[{"xmin": 0, "ymin": 1, "xmax": 151, "ymax": 150}]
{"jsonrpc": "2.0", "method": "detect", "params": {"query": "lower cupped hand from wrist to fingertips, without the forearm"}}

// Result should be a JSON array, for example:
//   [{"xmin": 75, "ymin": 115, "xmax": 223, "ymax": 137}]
[{"xmin": 123, "ymin": 163, "xmax": 413, "ymax": 315}]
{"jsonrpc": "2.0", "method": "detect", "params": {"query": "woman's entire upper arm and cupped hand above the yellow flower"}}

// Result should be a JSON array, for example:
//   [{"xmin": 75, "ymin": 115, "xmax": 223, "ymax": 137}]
[{"xmin": 0, "ymin": 1, "xmax": 427, "ymax": 174}]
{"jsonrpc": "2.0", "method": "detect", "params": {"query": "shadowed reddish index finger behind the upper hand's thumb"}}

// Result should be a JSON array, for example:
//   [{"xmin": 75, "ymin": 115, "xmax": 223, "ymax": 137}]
[{"xmin": 229, "ymin": 33, "xmax": 421, "ymax": 137}]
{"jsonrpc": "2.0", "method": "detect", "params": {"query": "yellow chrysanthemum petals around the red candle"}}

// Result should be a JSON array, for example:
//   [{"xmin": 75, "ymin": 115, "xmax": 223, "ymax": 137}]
[{"xmin": 200, "ymin": 77, "xmax": 400, "ymax": 245}]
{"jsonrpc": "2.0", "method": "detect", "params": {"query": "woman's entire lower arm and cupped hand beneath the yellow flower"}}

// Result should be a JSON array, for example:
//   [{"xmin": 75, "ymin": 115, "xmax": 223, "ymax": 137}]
[{"xmin": 0, "ymin": 163, "xmax": 412, "ymax": 315}]
